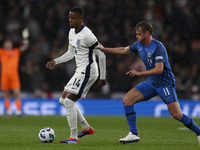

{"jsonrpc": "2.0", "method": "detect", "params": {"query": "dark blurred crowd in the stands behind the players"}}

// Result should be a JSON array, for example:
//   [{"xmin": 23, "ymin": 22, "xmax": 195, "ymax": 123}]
[{"xmin": 0, "ymin": 0, "xmax": 200, "ymax": 100}]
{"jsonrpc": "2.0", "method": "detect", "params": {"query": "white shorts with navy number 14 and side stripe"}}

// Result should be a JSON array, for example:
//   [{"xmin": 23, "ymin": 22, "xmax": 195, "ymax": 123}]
[{"xmin": 64, "ymin": 73, "xmax": 98, "ymax": 98}]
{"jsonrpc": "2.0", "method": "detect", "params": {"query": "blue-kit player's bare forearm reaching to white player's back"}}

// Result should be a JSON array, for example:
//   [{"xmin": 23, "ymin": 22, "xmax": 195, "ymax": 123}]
[{"xmin": 96, "ymin": 43, "xmax": 130, "ymax": 55}]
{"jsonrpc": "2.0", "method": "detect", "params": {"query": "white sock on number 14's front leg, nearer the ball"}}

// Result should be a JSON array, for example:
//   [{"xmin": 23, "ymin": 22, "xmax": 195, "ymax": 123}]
[{"xmin": 64, "ymin": 98, "xmax": 78, "ymax": 139}]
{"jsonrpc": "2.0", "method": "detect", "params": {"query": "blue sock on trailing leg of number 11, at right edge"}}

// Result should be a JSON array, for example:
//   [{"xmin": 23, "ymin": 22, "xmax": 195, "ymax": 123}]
[{"xmin": 180, "ymin": 114, "xmax": 200, "ymax": 136}]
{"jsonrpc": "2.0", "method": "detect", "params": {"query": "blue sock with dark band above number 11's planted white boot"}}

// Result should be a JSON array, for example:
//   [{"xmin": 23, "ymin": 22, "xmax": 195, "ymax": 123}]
[{"xmin": 124, "ymin": 105, "xmax": 138, "ymax": 135}]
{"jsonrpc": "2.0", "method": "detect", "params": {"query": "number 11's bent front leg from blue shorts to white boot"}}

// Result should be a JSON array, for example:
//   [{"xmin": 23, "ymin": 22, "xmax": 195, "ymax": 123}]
[{"xmin": 119, "ymin": 81, "xmax": 157, "ymax": 143}]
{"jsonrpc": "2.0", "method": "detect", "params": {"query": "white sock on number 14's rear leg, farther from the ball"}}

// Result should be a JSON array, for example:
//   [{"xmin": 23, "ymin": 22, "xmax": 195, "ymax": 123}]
[{"xmin": 74, "ymin": 105, "xmax": 90, "ymax": 130}]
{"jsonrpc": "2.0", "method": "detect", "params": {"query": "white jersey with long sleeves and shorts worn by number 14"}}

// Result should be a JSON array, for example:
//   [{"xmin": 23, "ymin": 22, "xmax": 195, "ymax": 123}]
[{"xmin": 54, "ymin": 24, "xmax": 106, "ymax": 97}]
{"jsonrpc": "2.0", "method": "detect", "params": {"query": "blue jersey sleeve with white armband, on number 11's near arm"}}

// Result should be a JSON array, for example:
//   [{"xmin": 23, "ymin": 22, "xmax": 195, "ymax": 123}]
[{"xmin": 155, "ymin": 45, "xmax": 165, "ymax": 63}]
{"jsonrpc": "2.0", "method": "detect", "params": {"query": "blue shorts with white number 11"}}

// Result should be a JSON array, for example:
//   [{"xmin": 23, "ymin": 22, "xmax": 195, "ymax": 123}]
[{"xmin": 135, "ymin": 81, "xmax": 178, "ymax": 104}]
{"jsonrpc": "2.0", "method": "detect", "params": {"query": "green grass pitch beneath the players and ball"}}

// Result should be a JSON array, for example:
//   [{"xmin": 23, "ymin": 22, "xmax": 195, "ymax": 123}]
[{"xmin": 0, "ymin": 116, "xmax": 200, "ymax": 150}]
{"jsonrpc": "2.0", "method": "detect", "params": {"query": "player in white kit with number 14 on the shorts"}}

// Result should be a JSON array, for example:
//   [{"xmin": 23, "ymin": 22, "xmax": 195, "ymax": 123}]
[{"xmin": 46, "ymin": 6, "xmax": 106, "ymax": 143}]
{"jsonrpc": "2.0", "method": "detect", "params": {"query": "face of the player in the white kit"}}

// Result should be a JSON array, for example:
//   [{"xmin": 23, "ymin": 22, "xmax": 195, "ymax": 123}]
[{"xmin": 69, "ymin": 12, "xmax": 83, "ymax": 28}]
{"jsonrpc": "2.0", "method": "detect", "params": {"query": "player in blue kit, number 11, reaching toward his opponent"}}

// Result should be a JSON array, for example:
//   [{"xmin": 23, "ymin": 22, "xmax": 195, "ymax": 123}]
[{"xmin": 96, "ymin": 21, "xmax": 200, "ymax": 143}]
